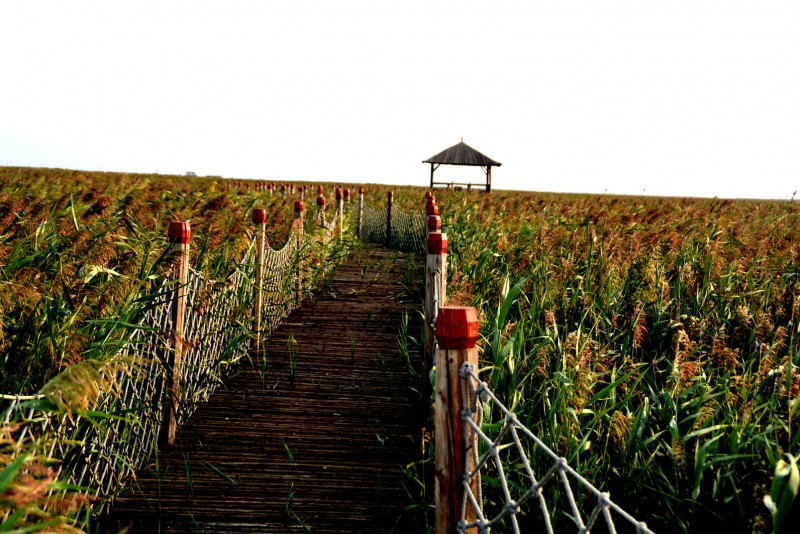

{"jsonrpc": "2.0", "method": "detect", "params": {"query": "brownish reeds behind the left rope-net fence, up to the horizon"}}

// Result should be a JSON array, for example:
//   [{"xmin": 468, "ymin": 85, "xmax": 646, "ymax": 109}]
[{"xmin": 0, "ymin": 167, "xmax": 302, "ymax": 394}]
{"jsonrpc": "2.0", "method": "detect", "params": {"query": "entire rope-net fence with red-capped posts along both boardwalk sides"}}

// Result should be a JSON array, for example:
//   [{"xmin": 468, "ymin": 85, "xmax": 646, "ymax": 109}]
[{"xmin": 0, "ymin": 185, "xmax": 651, "ymax": 534}]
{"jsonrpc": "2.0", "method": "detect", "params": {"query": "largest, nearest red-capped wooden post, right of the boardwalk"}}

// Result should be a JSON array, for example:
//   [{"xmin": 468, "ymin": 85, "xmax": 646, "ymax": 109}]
[{"xmin": 431, "ymin": 308, "xmax": 478, "ymax": 534}]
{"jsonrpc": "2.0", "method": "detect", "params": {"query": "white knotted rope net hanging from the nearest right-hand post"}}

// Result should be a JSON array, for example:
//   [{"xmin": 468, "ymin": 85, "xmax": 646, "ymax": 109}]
[{"xmin": 458, "ymin": 362, "xmax": 652, "ymax": 533}]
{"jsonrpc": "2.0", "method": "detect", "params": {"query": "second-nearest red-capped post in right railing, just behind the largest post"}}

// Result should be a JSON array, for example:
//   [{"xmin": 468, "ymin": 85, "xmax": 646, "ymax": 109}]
[{"xmin": 422, "ymin": 232, "xmax": 447, "ymax": 398}]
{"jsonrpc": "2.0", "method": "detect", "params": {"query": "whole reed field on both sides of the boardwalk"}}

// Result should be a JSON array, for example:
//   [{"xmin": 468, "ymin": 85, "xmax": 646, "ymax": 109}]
[{"xmin": 0, "ymin": 167, "xmax": 800, "ymax": 532}]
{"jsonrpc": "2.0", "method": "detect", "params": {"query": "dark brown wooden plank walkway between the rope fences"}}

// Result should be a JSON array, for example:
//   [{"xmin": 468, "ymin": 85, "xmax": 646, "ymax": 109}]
[{"xmin": 109, "ymin": 248, "xmax": 427, "ymax": 533}]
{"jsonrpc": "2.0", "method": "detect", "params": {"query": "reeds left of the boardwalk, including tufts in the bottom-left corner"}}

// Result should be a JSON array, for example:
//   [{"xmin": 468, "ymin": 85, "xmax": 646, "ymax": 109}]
[{"xmin": 0, "ymin": 168, "xmax": 345, "ymax": 531}]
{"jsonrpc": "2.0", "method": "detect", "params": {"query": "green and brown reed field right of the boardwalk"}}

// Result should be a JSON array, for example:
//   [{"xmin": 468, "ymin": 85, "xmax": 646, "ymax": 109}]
[{"xmin": 422, "ymin": 190, "xmax": 800, "ymax": 532}]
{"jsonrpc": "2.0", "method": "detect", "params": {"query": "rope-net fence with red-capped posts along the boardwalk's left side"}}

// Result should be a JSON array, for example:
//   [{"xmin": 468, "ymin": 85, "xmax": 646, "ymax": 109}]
[{"xmin": 0, "ymin": 189, "xmax": 344, "ymax": 521}]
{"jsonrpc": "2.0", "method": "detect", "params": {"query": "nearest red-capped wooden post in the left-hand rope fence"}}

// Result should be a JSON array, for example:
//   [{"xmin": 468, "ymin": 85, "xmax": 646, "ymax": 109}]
[{"xmin": 162, "ymin": 221, "xmax": 192, "ymax": 445}]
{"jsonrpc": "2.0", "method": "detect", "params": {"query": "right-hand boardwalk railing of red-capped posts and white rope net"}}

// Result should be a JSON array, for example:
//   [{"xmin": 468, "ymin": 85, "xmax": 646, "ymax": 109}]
[{"xmin": 406, "ymin": 194, "xmax": 651, "ymax": 534}]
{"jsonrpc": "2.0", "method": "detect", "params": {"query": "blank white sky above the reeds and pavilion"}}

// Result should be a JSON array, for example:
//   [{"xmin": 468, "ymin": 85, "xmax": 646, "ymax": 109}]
[{"xmin": 0, "ymin": 0, "xmax": 800, "ymax": 198}]
